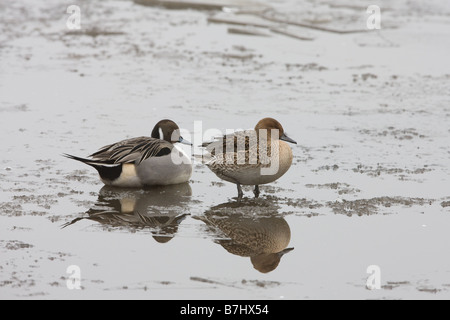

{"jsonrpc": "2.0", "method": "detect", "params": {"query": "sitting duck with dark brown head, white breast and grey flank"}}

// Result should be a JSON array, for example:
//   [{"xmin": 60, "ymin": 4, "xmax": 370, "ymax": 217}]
[{"xmin": 64, "ymin": 120, "xmax": 192, "ymax": 187}]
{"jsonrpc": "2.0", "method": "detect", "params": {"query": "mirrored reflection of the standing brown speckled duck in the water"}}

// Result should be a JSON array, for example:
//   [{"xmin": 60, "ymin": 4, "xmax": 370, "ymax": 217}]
[{"xmin": 194, "ymin": 200, "xmax": 294, "ymax": 273}]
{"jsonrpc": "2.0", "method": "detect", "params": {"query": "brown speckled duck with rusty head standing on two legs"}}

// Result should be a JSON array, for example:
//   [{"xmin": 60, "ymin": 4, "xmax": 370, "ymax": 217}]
[{"xmin": 203, "ymin": 118, "xmax": 297, "ymax": 199}]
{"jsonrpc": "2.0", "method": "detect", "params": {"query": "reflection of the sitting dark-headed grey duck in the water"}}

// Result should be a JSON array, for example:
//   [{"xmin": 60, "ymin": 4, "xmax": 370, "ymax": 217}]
[{"xmin": 63, "ymin": 183, "xmax": 192, "ymax": 243}]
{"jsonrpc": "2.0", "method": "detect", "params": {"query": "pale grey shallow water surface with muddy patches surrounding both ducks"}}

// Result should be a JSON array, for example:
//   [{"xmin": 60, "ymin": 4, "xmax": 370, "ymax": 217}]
[{"xmin": 0, "ymin": 0, "xmax": 450, "ymax": 299}]
